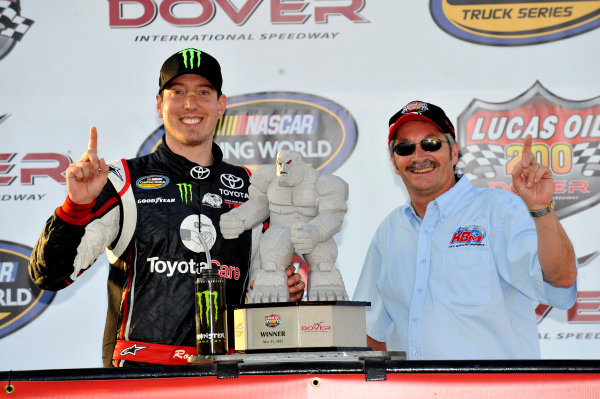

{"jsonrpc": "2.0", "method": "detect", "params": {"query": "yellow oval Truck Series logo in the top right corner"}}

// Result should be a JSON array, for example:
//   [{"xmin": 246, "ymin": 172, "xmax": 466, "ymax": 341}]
[{"xmin": 429, "ymin": 0, "xmax": 600, "ymax": 46}]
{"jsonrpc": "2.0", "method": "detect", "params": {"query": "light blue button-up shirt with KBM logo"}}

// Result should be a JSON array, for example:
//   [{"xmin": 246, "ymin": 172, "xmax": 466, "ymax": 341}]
[{"xmin": 354, "ymin": 177, "xmax": 577, "ymax": 359}]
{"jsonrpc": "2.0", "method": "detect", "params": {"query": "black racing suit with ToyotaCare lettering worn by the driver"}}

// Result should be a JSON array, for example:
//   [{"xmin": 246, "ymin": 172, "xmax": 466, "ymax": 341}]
[{"xmin": 29, "ymin": 137, "xmax": 252, "ymax": 366}]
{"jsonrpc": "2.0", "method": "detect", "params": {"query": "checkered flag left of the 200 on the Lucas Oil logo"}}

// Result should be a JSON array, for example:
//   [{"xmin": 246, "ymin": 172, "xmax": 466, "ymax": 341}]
[{"xmin": 456, "ymin": 144, "xmax": 507, "ymax": 180}]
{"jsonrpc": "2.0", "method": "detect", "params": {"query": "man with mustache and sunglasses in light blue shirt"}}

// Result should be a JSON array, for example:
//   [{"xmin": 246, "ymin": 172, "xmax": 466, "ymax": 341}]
[{"xmin": 354, "ymin": 101, "xmax": 577, "ymax": 359}]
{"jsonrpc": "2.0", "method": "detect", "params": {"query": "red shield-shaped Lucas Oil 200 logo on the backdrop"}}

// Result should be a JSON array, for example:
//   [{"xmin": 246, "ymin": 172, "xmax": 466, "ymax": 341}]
[{"xmin": 458, "ymin": 82, "xmax": 600, "ymax": 217}]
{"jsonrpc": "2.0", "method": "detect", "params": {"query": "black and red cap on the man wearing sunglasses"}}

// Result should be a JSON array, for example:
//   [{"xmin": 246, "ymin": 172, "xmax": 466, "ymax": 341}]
[{"xmin": 388, "ymin": 101, "xmax": 456, "ymax": 144}]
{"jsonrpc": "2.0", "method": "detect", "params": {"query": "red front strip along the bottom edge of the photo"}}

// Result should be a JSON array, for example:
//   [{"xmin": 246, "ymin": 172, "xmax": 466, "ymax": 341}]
[{"xmin": 11, "ymin": 374, "xmax": 600, "ymax": 399}]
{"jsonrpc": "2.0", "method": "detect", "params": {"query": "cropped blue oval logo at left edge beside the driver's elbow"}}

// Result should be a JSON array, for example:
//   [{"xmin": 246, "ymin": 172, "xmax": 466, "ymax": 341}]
[{"xmin": 0, "ymin": 241, "xmax": 56, "ymax": 338}]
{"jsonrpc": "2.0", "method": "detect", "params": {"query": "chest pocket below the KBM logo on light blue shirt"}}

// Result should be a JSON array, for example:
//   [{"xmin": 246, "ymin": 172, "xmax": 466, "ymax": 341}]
[{"xmin": 430, "ymin": 246, "xmax": 495, "ymax": 308}]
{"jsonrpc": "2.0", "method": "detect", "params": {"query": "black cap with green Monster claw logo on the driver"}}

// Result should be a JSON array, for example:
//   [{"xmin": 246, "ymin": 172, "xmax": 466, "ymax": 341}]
[{"xmin": 158, "ymin": 48, "xmax": 223, "ymax": 95}]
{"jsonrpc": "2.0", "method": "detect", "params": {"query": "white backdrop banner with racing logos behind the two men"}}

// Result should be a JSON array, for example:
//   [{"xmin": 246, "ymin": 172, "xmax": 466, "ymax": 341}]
[{"xmin": 0, "ymin": 0, "xmax": 600, "ymax": 370}]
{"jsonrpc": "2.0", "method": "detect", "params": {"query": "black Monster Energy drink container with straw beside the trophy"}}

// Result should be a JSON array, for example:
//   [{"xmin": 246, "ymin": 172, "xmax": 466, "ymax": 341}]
[{"xmin": 196, "ymin": 269, "xmax": 227, "ymax": 356}]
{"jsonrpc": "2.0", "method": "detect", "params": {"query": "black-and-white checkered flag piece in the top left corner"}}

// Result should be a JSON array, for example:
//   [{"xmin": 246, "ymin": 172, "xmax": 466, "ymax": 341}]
[{"xmin": 0, "ymin": 0, "xmax": 33, "ymax": 60}]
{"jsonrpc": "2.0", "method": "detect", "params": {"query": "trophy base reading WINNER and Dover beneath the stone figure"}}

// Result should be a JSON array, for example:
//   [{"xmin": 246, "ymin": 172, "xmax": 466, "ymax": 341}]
[{"xmin": 233, "ymin": 301, "xmax": 371, "ymax": 353}]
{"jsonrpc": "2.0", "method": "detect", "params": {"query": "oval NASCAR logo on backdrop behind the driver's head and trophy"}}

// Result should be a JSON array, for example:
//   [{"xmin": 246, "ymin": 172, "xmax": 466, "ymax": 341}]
[{"xmin": 138, "ymin": 92, "xmax": 358, "ymax": 173}]
